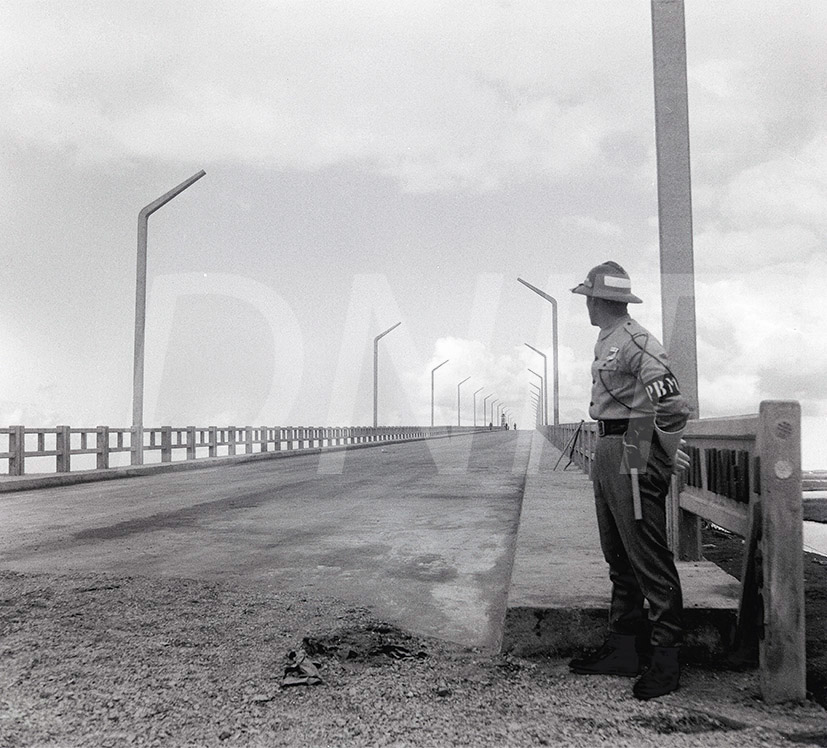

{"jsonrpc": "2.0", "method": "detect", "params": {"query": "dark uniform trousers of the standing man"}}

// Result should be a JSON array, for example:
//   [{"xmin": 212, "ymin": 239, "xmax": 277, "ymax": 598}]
[{"xmin": 592, "ymin": 436, "xmax": 683, "ymax": 647}]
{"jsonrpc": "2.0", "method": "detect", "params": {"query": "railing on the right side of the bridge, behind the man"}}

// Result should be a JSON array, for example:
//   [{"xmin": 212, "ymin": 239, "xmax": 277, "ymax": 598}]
[{"xmin": 547, "ymin": 401, "xmax": 806, "ymax": 703}]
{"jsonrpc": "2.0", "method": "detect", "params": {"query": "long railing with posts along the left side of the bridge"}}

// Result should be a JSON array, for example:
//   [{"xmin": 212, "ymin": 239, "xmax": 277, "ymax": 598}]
[{"xmin": 0, "ymin": 426, "xmax": 486, "ymax": 476}]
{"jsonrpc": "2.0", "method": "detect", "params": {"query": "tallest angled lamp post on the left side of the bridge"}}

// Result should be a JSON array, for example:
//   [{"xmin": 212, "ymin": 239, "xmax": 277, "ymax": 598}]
[{"xmin": 131, "ymin": 169, "xmax": 206, "ymax": 465}]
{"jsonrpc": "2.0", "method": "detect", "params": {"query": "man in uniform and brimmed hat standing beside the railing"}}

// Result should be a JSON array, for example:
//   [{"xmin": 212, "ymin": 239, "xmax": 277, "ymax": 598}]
[{"xmin": 569, "ymin": 262, "xmax": 690, "ymax": 700}]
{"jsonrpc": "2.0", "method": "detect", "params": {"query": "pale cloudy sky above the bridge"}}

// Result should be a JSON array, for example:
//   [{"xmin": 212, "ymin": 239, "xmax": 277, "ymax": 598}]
[{"xmin": 0, "ymin": 0, "xmax": 827, "ymax": 468}]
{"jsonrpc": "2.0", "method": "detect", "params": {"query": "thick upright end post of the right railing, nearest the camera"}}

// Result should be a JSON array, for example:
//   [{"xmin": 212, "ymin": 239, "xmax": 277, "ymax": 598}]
[{"xmin": 756, "ymin": 400, "xmax": 807, "ymax": 704}]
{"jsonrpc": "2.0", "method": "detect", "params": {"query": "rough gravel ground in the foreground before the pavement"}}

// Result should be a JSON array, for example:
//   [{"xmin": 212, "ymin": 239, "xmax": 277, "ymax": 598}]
[{"xmin": 0, "ymin": 572, "xmax": 827, "ymax": 748}]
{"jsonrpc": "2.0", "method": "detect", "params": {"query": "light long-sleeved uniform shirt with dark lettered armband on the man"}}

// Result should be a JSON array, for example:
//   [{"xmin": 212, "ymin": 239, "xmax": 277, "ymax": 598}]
[{"xmin": 589, "ymin": 314, "xmax": 690, "ymax": 431}]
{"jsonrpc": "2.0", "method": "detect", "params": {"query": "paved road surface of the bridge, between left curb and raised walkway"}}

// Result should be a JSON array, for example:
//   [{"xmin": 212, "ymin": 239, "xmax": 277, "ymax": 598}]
[{"xmin": 0, "ymin": 431, "xmax": 531, "ymax": 648}]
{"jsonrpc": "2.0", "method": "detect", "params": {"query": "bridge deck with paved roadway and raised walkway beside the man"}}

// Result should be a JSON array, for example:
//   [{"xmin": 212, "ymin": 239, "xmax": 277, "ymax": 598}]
[{"xmin": 0, "ymin": 430, "xmax": 739, "ymax": 655}]
